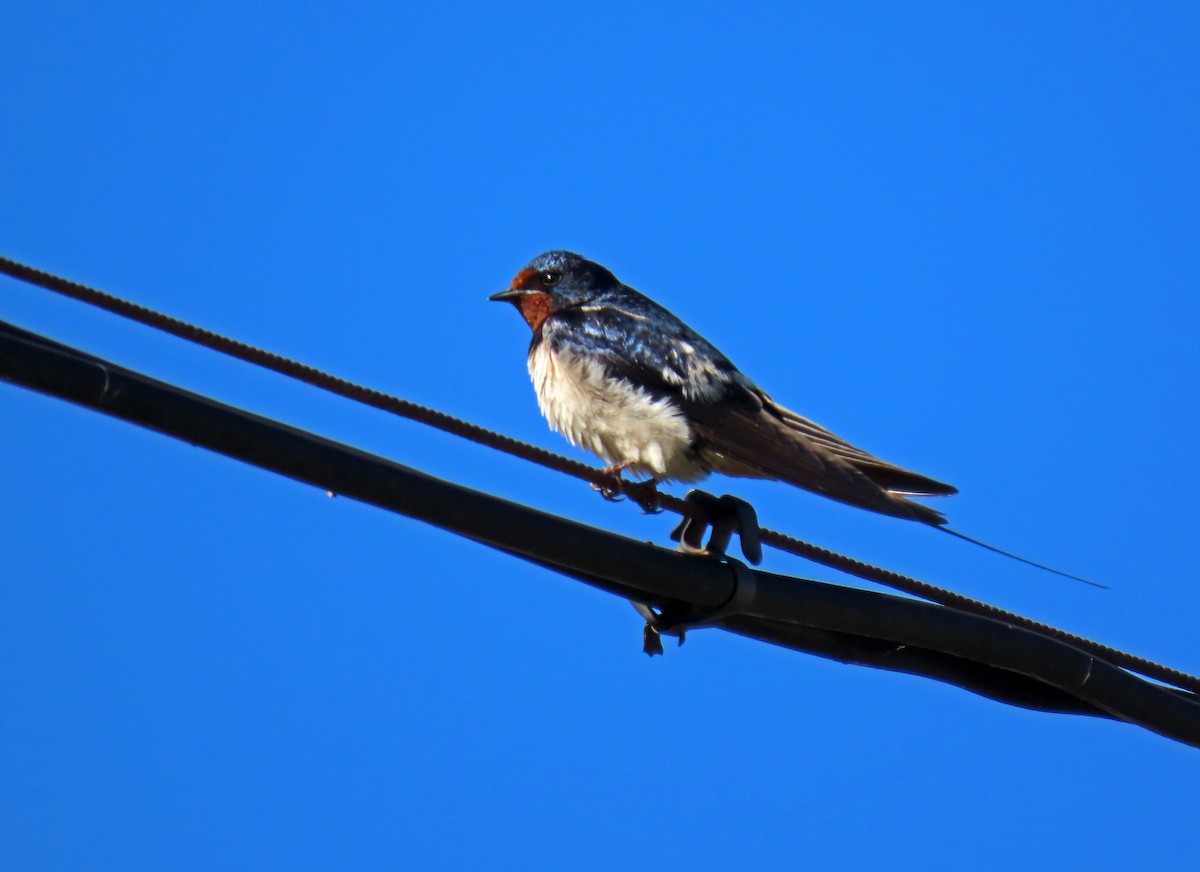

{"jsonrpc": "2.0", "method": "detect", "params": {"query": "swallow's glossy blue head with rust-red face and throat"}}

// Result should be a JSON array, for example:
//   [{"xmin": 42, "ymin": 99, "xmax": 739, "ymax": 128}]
[{"xmin": 487, "ymin": 251, "xmax": 620, "ymax": 330}]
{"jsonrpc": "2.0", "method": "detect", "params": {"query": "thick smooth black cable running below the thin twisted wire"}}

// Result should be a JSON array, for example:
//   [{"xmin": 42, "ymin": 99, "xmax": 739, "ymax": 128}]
[{"xmin": 0, "ymin": 323, "xmax": 1200, "ymax": 747}]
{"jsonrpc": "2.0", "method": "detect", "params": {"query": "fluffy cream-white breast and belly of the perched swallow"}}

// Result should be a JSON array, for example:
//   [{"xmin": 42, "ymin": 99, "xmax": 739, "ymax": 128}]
[{"xmin": 529, "ymin": 342, "xmax": 707, "ymax": 481}]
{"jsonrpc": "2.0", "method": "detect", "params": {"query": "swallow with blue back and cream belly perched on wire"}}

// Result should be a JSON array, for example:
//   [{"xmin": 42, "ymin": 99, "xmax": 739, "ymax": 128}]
[{"xmin": 490, "ymin": 251, "xmax": 955, "ymax": 525}]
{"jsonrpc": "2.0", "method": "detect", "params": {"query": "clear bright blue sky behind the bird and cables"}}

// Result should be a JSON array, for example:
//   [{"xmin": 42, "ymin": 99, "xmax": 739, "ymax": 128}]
[{"xmin": 0, "ymin": 2, "xmax": 1200, "ymax": 870}]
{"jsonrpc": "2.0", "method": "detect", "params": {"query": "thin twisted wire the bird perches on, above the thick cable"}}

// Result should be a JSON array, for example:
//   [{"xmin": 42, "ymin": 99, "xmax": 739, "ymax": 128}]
[{"xmin": 0, "ymin": 255, "xmax": 1200, "ymax": 693}]
